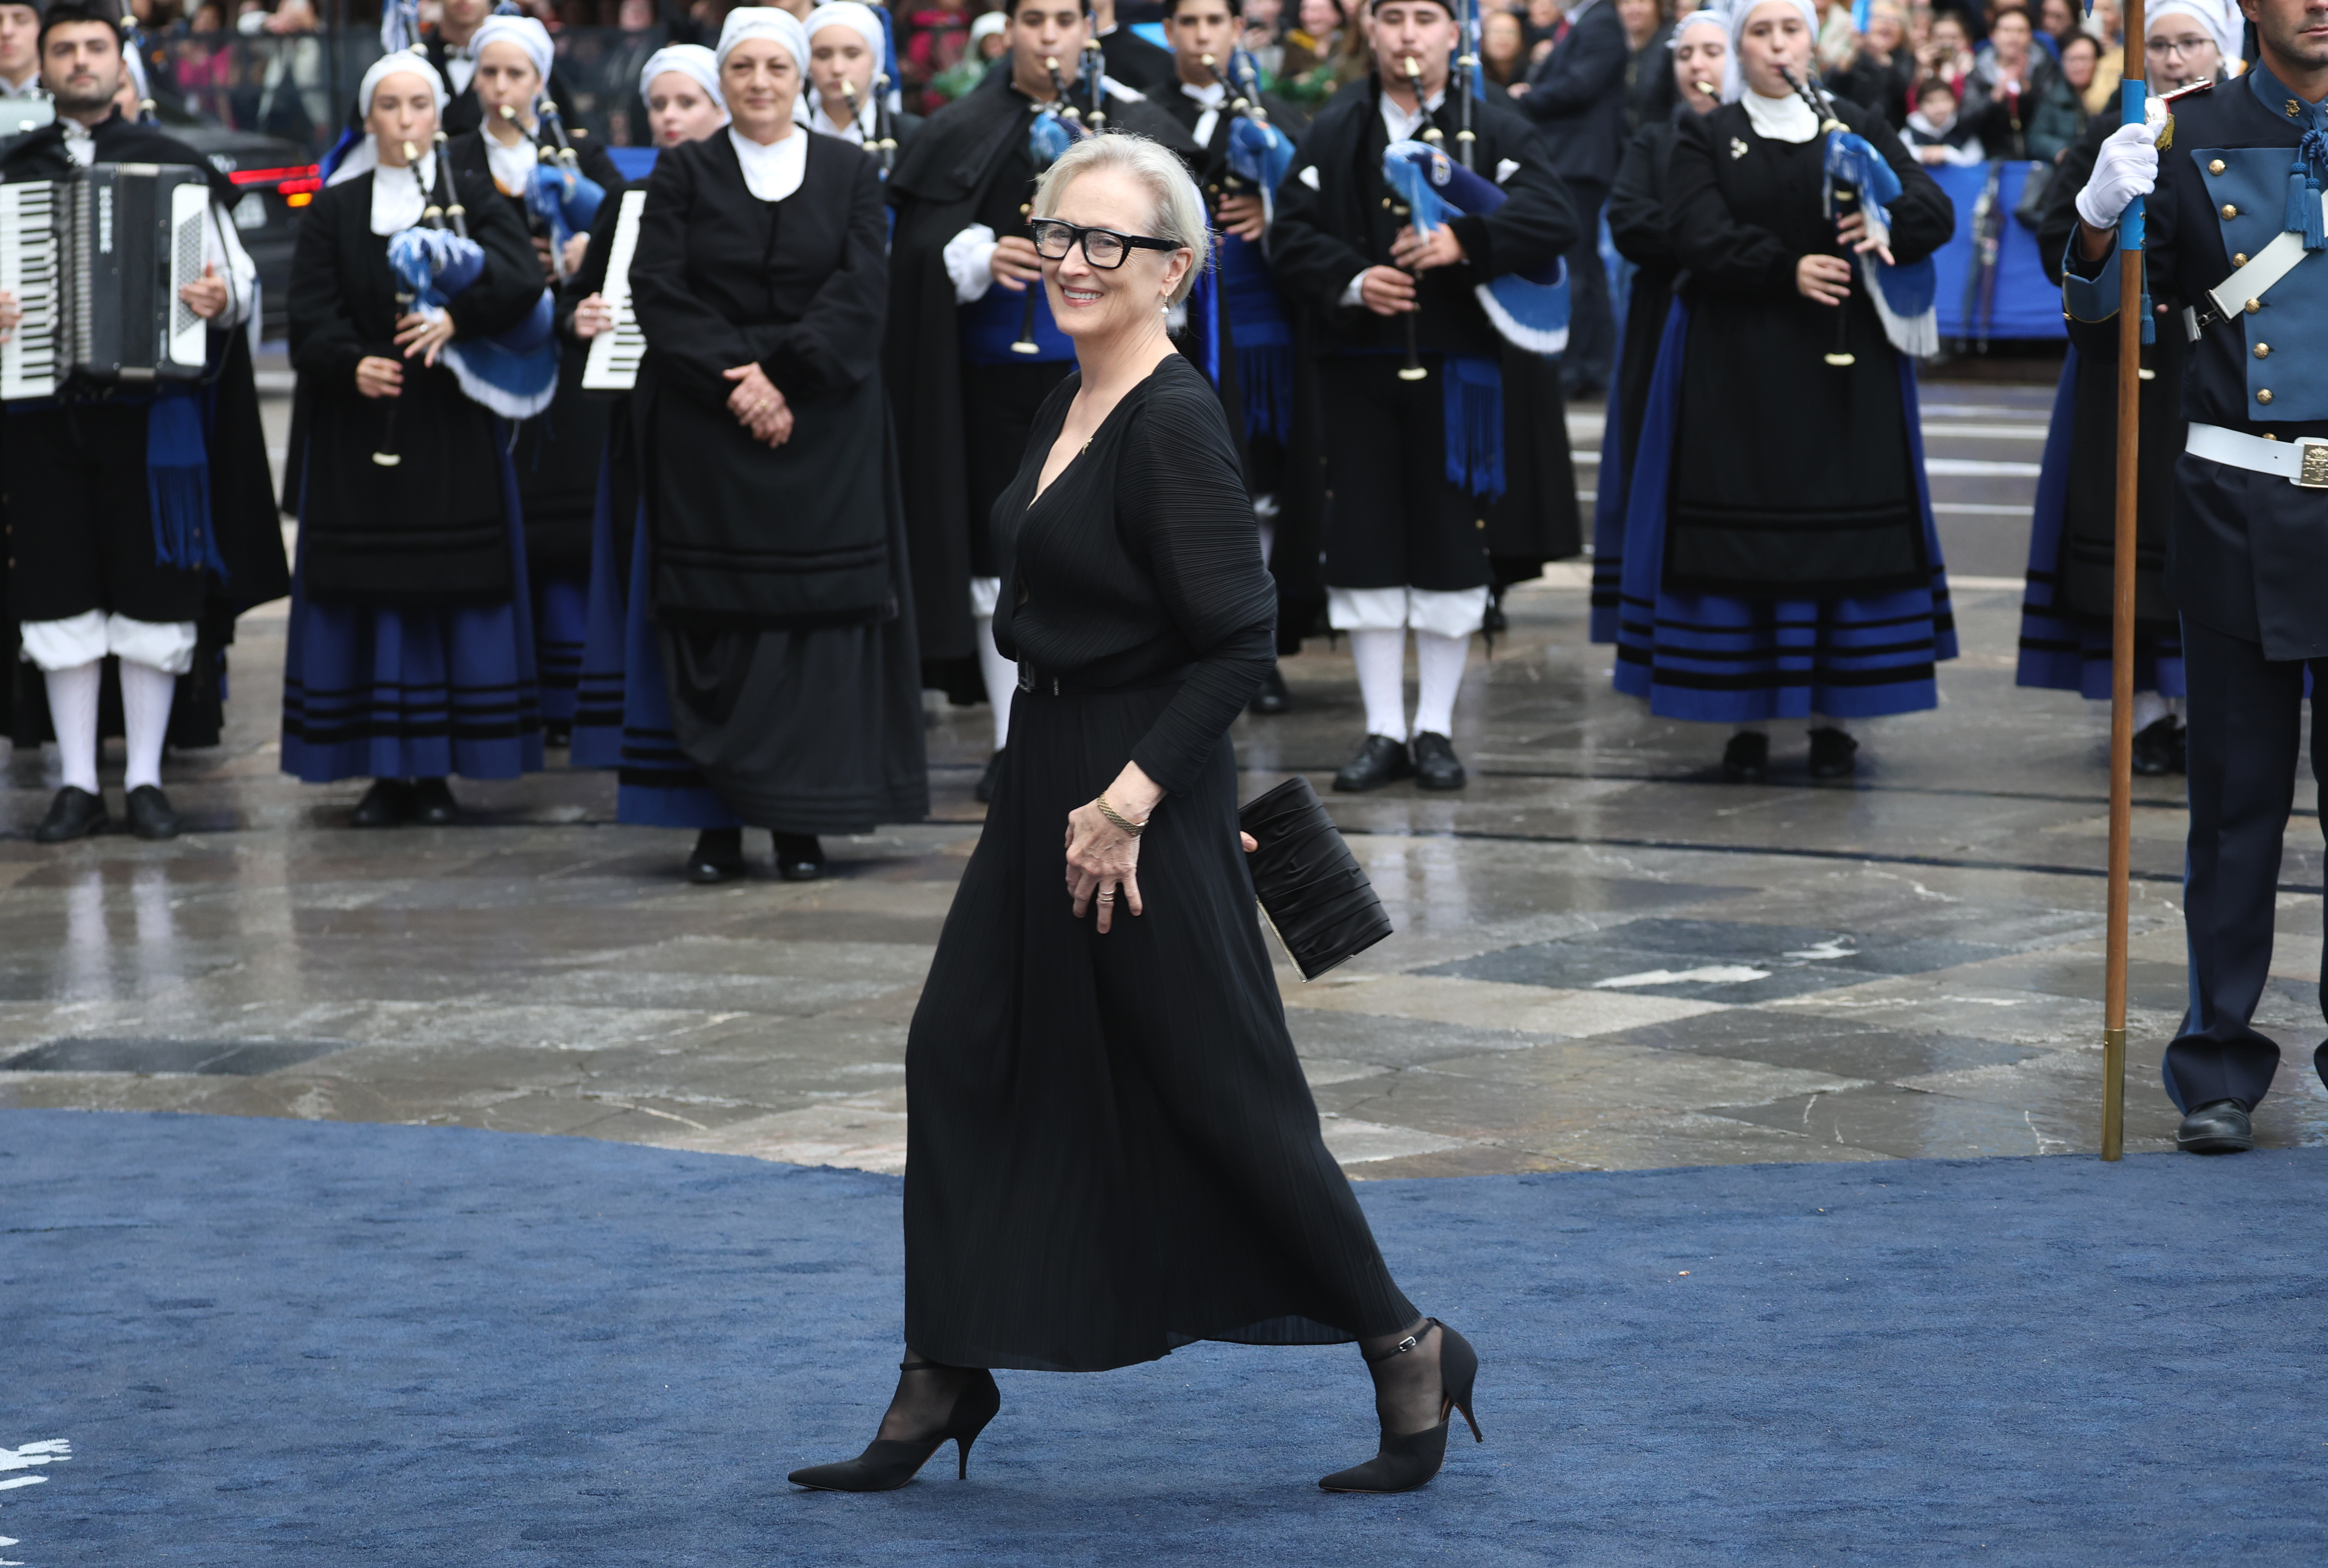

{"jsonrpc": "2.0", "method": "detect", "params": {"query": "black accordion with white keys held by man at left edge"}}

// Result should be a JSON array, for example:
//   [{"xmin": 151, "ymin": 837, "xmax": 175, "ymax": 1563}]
[{"xmin": 0, "ymin": 163, "xmax": 209, "ymax": 400}]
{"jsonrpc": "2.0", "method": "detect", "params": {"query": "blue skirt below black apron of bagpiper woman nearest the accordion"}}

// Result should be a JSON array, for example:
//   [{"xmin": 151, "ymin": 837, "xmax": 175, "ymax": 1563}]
[{"xmin": 282, "ymin": 432, "xmax": 543, "ymax": 784}]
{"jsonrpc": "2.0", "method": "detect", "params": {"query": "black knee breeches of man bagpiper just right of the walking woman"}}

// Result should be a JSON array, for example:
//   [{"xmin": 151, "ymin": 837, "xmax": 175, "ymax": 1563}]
[{"xmin": 1318, "ymin": 354, "xmax": 1513, "ymax": 593}]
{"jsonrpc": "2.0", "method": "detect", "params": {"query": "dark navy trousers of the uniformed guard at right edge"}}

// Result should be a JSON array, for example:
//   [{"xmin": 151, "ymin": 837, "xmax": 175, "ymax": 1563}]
[{"xmin": 2165, "ymin": 619, "xmax": 2328, "ymax": 1110}]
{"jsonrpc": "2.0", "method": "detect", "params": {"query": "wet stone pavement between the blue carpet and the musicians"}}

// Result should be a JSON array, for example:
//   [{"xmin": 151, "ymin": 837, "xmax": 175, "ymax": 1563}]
[{"xmin": 0, "ymin": 372, "xmax": 2328, "ymax": 1177}]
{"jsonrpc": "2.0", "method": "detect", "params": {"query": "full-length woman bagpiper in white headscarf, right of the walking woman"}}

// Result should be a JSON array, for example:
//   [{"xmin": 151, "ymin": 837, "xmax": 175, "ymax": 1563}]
[{"xmin": 1616, "ymin": 0, "xmax": 1956, "ymax": 782}]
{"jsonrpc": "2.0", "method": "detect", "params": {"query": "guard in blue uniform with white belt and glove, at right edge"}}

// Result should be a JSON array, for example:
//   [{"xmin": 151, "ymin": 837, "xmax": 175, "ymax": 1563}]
[{"xmin": 2063, "ymin": 0, "xmax": 2328, "ymax": 1154}]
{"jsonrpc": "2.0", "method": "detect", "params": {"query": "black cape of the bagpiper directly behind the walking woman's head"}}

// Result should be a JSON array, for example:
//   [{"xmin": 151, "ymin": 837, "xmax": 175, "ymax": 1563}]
[{"xmin": 882, "ymin": 70, "xmax": 1194, "ymax": 661}]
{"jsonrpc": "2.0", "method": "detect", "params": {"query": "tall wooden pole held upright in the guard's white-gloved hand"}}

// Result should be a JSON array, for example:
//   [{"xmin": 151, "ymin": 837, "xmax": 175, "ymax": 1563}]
[{"xmin": 2102, "ymin": 0, "xmax": 2149, "ymax": 1161}]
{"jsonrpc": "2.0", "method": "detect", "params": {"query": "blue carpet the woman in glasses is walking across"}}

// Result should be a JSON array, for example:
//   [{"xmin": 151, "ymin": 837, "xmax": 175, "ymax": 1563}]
[{"xmin": 0, "ymin": 1112, "xmax": 2328, "ymax": 1568}]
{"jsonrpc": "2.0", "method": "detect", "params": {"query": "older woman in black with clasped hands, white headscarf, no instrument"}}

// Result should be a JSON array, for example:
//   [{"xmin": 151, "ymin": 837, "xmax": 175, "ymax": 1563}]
[{"xmin": 631, "ymin": 7, "xmax": 929, "ymax": 882}]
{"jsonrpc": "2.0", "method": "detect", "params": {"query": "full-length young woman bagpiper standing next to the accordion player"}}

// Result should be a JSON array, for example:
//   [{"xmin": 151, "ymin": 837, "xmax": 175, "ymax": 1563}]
[{"xmin": 282, "ymin": 53, "xmax": 543, "ymax": 826}]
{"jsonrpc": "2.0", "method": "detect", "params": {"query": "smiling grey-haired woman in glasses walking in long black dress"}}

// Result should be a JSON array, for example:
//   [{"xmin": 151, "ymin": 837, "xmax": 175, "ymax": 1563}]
[{"xmin": 791, "ymin": 135, "xmax": 1478, "ymax": 1491}]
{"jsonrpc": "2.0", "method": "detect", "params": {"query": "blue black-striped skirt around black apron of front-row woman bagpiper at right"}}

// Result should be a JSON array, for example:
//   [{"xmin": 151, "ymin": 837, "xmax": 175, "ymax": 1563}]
[{"xmin": 1602, "ymin": 300, "xmax": 1956, "ymax": 723}]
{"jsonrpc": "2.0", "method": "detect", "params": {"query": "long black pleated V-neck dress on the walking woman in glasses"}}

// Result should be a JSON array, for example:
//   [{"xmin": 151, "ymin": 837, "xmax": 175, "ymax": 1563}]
[{"xmin": 905, "ymin": 356, "xmax": 1418, "ymax": 1372}]
